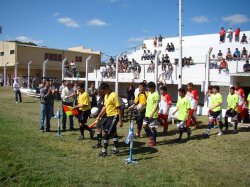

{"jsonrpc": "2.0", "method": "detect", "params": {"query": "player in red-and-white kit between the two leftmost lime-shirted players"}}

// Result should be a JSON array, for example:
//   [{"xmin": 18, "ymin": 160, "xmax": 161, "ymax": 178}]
[{"xmin": 158, "ymin": 86, "xmax": 172, "ymax": 135}]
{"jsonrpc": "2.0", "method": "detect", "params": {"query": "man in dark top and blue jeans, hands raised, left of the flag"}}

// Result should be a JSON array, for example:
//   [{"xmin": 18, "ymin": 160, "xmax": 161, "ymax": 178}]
[{"xmin": 40, "ymin": 80, "xmax": 55, "ymax": 132}]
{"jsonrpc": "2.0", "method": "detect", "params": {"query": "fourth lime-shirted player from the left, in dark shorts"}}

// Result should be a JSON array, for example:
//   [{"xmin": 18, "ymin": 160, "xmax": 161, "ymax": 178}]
[{"xmin": 225, "ymin": 87, "xmax": 239, "ymax": 134}]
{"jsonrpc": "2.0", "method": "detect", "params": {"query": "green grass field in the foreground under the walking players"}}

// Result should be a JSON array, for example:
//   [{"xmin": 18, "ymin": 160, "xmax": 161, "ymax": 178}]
[{"xmin": 0, "ymin": 88, "xmax": 250, "ymax": 187}]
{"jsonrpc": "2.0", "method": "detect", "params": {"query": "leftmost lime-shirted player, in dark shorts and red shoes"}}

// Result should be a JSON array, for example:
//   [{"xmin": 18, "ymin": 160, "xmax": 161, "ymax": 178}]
[{"xmin": 143, "ymin": 82, "xmax": 160, "ymax": 146}]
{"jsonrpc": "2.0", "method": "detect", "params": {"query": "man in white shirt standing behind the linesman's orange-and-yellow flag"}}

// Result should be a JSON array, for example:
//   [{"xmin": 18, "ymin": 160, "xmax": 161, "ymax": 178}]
[{"xmin": 61, "ymin": 82, "xmax": 76, "ymax": 131}]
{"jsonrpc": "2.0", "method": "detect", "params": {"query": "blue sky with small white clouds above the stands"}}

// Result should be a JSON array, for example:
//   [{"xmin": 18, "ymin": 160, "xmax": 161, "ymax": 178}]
[{"xmin": 0, "ymin": 0, "xmax": 250, "ymax": 55}]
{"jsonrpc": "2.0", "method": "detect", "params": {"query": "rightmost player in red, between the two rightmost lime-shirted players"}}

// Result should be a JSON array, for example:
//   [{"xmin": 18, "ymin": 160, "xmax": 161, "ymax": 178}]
[{"xmin": 234, "ymin": 82, "xmax": 246, "ymax": 122}]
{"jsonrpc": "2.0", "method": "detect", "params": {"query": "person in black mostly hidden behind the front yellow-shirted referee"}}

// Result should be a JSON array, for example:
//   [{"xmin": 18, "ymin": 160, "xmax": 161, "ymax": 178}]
[{"xmin": 92, "ymin": 90, "xmax": 106, "ymax": 148}]
